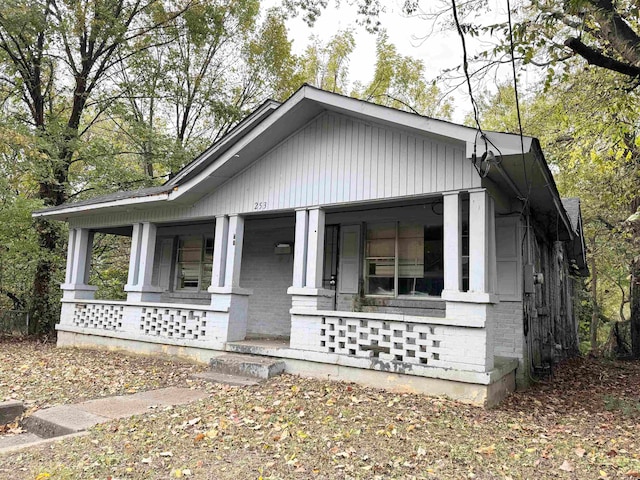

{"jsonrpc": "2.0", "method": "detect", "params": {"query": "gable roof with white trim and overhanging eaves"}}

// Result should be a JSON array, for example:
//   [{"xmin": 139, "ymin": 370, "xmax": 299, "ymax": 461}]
[{"xmin": 33, "ymin": 84, "xmax": 575, "ymax": 260}]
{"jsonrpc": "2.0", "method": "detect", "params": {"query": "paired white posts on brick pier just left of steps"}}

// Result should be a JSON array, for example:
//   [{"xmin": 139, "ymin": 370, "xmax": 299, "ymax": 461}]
[{"xmin": 208, "ymin": 215, "xmax": 253, "ymax": 342}]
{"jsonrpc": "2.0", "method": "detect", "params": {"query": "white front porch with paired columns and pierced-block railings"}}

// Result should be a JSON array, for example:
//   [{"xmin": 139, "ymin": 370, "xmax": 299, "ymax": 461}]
[{"xmin": 56, "ymin": 189, "xmax": 518, "ymax": 403}]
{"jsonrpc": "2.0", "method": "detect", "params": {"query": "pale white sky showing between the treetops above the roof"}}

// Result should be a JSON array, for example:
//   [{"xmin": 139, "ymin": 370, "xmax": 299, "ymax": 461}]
[{"xmin": 263, "ymin": 0, "xmax": 528, "ymax": 123}]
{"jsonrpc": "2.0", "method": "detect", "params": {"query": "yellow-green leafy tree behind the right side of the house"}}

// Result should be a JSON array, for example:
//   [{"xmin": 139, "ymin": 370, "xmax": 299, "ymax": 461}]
[{"xmin": 479, "ymin": 68, "xmax": 640, "ymax": 353}]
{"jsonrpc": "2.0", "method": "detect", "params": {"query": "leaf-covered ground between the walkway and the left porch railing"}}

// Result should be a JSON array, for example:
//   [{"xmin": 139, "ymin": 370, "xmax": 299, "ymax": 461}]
[{"xmin": 0, "ymin": 337, "xmax": 206, "ymax": 435}]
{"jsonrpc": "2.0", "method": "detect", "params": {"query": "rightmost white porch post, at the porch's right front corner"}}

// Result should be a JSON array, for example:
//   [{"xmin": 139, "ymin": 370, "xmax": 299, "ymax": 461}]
[{"xmin": 469, "ymin": 189, "xmax": 490, "ymax": 293}]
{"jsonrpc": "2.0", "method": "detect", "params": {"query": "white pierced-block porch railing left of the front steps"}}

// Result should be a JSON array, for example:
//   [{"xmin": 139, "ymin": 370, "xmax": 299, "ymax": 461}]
[{"xmin": 57, "ymin": 300, "xmax": 228, "ymax": 347}]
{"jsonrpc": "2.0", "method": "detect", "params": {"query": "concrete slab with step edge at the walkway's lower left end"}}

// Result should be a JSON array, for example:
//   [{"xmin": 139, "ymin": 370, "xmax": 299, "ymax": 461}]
[{"xmin": 24, "ymin": 405, "xmax": 109, "ymax": 438}]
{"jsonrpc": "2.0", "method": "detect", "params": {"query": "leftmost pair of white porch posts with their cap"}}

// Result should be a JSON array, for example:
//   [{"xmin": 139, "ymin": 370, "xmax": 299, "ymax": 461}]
[{"xmin": 60, "ymin": 228, "xmax": 98, "ymax": 300}]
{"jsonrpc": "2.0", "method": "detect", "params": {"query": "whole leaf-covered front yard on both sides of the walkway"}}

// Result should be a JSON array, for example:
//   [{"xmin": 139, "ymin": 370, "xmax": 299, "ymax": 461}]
[{"xmin": 0, "ymin": 343, "xmax": 640, "ymax": 480}]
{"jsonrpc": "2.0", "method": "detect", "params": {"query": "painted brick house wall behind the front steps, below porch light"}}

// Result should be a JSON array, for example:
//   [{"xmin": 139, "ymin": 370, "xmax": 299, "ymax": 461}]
[{"xmin": 240, "ymin": 218, "xmax": 294, "ymax": 336}]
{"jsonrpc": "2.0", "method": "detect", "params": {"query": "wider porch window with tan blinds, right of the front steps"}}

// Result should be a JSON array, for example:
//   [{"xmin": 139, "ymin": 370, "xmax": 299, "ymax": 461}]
[{"xmin": 365, "ymin": 222, "xmax": 444, "ymax": 297}]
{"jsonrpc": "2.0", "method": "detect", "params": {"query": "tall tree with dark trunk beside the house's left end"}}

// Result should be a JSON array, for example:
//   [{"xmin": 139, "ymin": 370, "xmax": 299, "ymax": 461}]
[{"xmin": 0, "ymin": 0, "xmax": 185, "ymax": 330}]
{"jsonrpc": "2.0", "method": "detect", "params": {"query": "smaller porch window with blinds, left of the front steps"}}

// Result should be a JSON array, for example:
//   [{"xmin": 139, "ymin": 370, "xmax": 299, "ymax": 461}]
[{"xmin": 176, "ymin": 235, "xmax": 213, "ymax": 290}]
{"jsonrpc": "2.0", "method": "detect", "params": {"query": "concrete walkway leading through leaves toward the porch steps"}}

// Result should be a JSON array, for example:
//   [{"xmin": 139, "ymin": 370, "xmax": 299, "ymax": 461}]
[{"xmin": 0, "ymin": 387, "xmax": 208, "ymax": 454}]
